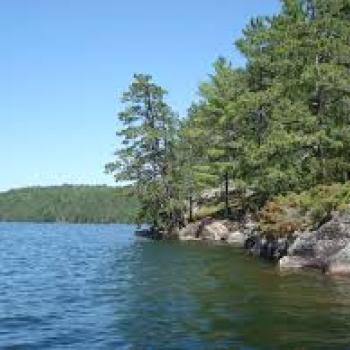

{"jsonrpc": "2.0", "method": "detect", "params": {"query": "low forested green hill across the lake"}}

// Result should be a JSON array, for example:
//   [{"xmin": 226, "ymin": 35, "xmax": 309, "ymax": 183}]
[{"xmin": 0, "ymin": 185, "xmax": 137, "ymax": 223}]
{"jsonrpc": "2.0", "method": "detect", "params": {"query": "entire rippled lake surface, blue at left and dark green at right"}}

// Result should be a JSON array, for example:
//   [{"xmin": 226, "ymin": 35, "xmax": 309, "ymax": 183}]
[{"xmin": 0, "ymin": 224, "xmax": 350, "ymax": 350}]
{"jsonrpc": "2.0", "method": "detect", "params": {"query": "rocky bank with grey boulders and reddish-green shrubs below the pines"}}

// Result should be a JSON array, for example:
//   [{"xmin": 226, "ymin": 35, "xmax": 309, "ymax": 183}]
[{"xmin": 137, "ymin": 180, "xmax": 350, "ymax": 276}]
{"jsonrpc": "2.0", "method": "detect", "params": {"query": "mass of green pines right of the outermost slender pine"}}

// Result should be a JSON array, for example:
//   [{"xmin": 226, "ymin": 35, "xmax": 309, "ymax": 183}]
[{"xmin": 178, "ymin": 0, "xmax": 350, "ymax": 211}]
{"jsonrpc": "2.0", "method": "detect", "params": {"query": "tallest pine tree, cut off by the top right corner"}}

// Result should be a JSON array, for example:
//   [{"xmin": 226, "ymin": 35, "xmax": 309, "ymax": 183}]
[{"xmin": 273, "ymin": 0, "xmax": 350, "ymax": 184}]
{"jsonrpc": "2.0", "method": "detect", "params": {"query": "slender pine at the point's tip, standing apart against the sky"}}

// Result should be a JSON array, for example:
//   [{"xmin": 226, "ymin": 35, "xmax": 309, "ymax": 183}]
[{"xmin": 106, "ymin": 74, "xmax": 177, "ymax": 230}]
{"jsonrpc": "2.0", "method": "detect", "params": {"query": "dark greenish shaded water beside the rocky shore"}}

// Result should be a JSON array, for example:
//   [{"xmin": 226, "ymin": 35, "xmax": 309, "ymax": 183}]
[{"xmin": 104, "ymin": 242, "xmax": 350, "ymax": 349}]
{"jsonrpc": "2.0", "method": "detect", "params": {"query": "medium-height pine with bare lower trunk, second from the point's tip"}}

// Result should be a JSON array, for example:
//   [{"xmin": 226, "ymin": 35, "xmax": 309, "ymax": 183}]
[{"xmin": 186, "ymin": 58, "xmax": 245, "ymax": 217}]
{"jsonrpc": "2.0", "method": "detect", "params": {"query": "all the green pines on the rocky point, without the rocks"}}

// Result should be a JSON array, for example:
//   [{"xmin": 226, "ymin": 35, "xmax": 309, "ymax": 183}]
[{"xmin": 107, "ymin": 0, "xmax": 350, "ymax": 232}]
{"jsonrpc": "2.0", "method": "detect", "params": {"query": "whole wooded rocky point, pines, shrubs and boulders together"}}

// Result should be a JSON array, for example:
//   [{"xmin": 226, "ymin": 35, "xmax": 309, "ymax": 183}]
[{"xmin": 107, "ymin": 1, "xmax": 350, "ymax": 274}]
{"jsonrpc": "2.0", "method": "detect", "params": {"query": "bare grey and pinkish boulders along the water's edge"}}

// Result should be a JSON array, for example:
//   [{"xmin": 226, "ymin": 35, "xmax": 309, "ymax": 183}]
[{"xmin": 170, "ymin": 212, "xmax": 350, "ymax": 276}]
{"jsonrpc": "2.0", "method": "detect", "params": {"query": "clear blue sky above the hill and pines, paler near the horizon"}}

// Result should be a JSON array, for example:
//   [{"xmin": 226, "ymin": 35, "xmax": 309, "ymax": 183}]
[{"xmin": 0, "ymin": 0, "xmax": 279, "ymax": 191}]
